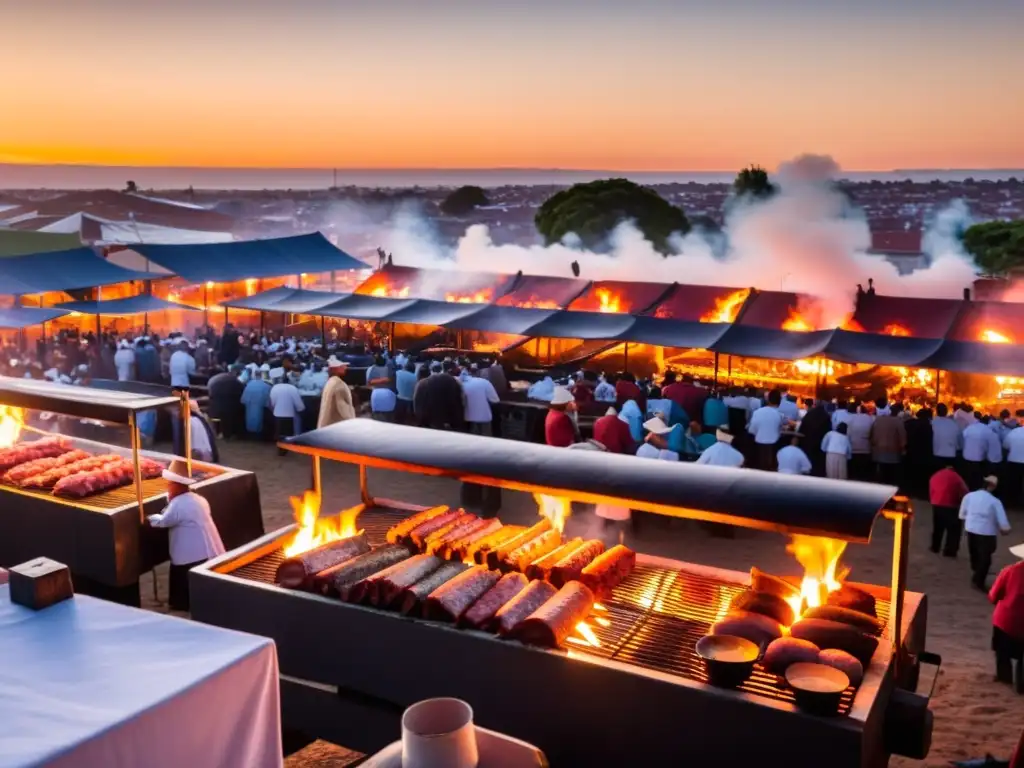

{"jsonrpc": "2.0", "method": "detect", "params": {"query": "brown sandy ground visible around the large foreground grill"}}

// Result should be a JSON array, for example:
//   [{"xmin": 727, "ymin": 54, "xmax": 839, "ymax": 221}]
[{"xmin": 142, "ymin": 442, "xmax": 1024, "ymax": 768}]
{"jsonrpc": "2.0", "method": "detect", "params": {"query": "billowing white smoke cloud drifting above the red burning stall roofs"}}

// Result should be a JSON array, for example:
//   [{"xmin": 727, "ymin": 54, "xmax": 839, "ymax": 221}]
[{"xmin": 323, "ymin": 155, "xmax": 978, "ymax": 328}]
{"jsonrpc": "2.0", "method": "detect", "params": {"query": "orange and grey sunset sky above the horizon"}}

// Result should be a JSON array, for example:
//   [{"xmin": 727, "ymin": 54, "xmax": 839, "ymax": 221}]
[{"xmin": 0, "ymin": 0, "xmax": 1024, "ymax": 171}]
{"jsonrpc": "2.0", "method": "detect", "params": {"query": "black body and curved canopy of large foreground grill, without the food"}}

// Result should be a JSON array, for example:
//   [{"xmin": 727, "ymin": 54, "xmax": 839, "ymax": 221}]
[{"xmin": 191, "ymin": 422, "xmax": 931, "ymax": 768}]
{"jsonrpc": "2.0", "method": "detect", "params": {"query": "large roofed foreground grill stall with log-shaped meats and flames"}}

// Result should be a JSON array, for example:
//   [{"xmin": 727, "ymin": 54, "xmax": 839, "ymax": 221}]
[{"xmin": 190, "ymin": 420, "xmax": 936, "ymax": 768}]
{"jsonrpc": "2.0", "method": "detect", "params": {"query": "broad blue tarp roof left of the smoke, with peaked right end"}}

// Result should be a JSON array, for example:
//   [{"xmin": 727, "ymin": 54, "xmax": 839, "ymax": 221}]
[{"xmin": 133, "ymin": 232, "xmax": 367, "ymax": 283}]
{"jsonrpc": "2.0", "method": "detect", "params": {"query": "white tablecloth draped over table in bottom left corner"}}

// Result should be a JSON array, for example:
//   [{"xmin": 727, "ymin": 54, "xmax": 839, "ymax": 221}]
[{"xmin": 0, "ymin": 586, "xmax": 283, "ymax": 768}]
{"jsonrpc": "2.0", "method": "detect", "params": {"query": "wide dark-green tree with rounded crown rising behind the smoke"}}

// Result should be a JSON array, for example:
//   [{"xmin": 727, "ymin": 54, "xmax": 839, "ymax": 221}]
[{"xmin": 534, "ymin": 178, "xmax": 690, "ymax": 253}]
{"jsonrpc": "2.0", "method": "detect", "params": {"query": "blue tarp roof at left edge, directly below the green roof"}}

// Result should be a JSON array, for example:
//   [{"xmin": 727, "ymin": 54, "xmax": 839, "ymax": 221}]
[{"xmin": 0, "ymin": 248, "xmax": 155, "ymax": 293}]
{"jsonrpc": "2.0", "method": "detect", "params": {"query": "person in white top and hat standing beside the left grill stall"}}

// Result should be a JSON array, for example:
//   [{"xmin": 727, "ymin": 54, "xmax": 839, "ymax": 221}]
[{"xmin": 146, "ymin": 459, "xmax": 224, "ymax": 611}]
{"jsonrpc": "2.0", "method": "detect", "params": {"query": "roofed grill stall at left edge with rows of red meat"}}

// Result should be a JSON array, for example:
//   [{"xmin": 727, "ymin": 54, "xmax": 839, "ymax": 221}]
[{"xmin": 0, "ymin": 377, "xmax": 264, "ymax": 605}]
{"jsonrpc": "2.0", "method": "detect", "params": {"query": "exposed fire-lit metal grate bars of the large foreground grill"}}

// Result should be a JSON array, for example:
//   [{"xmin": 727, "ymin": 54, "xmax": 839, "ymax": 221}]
[{"xmin": 222, "ymin": 507, "xmax": 889, "ymax": 715}]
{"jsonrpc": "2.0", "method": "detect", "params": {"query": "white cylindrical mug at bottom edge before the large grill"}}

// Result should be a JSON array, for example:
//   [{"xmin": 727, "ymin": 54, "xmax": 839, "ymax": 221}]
[{"xmin": 401, "ymin": 698, "xmax": 480, "ymax": 768}]
